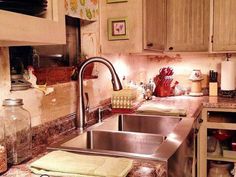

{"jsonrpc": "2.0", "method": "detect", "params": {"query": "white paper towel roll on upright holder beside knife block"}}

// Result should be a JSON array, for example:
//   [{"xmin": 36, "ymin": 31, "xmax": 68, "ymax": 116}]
[{"xmin": 220, "ymin": 53, "xmax": 236, "ymax": 97}]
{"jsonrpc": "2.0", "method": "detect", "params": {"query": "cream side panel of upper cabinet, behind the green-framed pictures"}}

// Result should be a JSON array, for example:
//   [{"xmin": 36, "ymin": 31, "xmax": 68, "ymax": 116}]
[{"xmin": 100, "ymin": 0, "xmax": 143, "ymax": 54}]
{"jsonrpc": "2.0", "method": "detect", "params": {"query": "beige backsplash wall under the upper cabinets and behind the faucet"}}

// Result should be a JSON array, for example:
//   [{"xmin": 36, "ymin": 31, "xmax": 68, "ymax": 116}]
[{"xmin": 85, "ymin": 54, "xmax": 236, "ymax": 108}]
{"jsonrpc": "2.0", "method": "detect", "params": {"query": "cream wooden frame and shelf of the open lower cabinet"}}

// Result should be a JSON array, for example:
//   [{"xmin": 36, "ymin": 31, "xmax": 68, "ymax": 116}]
[{"xmin": 198, "ymin": 108, "xmax": 236, "ymax": 177}]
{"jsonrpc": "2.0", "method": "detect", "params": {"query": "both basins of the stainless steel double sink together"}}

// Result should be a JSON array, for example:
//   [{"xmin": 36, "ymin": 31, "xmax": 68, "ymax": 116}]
[{"xmin": 52, "ymin": 114, "xmax": 181, "ymax": 160}]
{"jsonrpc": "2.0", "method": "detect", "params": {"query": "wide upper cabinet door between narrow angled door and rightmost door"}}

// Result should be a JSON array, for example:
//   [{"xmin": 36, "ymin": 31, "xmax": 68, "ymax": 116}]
[{"xmin": 166, "ymin": 0, "xmax": 209, "ymax": 52}]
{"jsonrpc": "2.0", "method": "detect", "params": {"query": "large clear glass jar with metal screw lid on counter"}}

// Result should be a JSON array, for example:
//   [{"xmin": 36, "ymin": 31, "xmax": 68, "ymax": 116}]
[{"xmin": 1, "ymin": 99, "xmax": 32, "ymax": 165}]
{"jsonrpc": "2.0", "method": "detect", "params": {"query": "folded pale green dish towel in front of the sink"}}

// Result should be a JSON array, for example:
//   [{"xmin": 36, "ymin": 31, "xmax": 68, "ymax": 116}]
[{"xmin": 29, "ymin": 151, "xmax": 133, "ymax": 177}]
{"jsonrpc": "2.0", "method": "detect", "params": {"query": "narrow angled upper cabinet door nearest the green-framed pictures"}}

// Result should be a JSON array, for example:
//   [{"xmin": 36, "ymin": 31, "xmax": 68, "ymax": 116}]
[{"xmin": 143, "ymin": 0, "xmax": 166, "ymax": 51}]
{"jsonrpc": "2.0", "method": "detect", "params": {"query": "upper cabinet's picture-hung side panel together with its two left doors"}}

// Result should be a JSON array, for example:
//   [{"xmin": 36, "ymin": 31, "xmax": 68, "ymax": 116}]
[{"xmin": 100, "ymin": 0, "xmax": 210, "ymax": 53}]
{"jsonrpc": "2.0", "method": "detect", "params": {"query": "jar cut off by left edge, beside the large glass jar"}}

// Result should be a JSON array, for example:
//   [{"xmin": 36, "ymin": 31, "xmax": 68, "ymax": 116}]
[{"xmin": 0, "ymin": 117, "xmax": 7, "ymax": 175}]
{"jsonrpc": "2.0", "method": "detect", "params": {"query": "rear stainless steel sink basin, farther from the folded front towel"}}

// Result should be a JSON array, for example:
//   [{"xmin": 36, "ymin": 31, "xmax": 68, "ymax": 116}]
[{"xmin": 95, "ymin": 114, "xmax": 181, "ymax": 136}]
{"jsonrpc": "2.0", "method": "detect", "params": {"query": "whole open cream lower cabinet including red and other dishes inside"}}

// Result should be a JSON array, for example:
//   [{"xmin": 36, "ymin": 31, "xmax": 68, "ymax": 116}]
[{"xmin": 198, "ymin": 108, "xmax": 236, "ymax": 177}]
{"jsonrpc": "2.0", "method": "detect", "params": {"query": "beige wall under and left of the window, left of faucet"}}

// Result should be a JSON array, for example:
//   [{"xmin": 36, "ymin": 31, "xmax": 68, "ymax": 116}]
[{"xmin": 0, "ymin": 48, "xmax": 77, "ymax": 126}]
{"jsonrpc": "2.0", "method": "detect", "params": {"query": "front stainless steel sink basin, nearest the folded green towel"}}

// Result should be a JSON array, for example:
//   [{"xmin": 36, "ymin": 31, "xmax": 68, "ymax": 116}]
[{"xmin": 61, "ymin": 130, "xmax": 165, "ymax": 155}]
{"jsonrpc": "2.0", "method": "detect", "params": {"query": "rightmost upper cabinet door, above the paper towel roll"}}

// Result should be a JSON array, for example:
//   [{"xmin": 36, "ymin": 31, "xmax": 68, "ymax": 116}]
[{"xmin": 213, "ymin": 0, "xmax": 236, "ymax": 51}]
